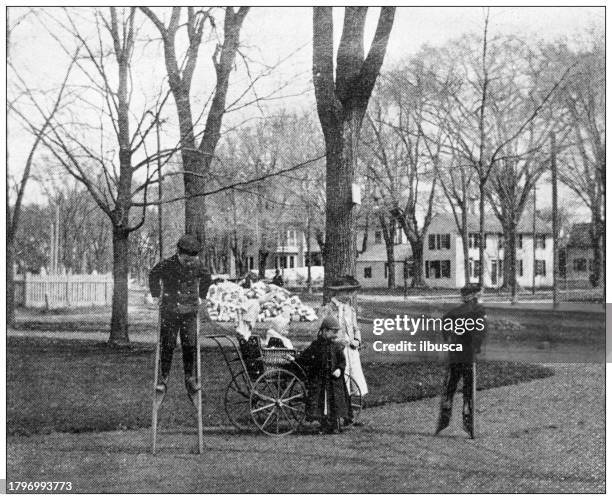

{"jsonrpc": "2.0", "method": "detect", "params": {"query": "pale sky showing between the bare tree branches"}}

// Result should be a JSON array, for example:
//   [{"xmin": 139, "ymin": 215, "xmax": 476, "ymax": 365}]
[{"xmin": 8, "ymin": 7, "xmax": 604, "ymax": 217}]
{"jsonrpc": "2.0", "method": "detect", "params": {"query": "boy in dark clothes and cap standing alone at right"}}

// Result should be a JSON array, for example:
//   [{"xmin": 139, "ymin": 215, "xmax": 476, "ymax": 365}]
[{"xmin": 436, "ymin": 284, "xmax": 487, "ymax": 439}]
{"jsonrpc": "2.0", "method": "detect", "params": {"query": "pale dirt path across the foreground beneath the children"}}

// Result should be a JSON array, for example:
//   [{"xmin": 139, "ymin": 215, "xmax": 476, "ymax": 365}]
[{"xmin": 7, "ymin": 364, "xmax": 605, "ymax": 493}]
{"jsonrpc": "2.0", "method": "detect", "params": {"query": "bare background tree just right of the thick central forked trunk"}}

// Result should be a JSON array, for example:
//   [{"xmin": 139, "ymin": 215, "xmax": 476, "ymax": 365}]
[{"xmin": 368, "ymin": 62, "xmax": 441, "ymax": 287}]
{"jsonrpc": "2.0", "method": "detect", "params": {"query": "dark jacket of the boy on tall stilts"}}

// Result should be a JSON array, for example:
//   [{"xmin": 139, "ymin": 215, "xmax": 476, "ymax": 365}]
[{"xmin": 149, "ymin": 255, "xmax": 211, "ymax": 314}]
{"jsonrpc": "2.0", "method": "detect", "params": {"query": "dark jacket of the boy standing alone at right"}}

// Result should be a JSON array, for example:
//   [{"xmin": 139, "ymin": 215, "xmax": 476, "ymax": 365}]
[{"xmin": 443, "ymin": 302, "xmax": 487, "ymax": 363}]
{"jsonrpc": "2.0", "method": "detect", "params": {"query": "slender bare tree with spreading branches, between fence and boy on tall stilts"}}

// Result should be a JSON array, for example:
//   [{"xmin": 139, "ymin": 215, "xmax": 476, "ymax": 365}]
[{"xmin": 25, "ymin": 7, "xmax": 174, "ymax": 344}]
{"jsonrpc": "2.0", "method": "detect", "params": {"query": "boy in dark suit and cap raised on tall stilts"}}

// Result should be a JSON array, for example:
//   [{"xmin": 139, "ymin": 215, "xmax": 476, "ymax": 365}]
[{"xmin": 149, "ymin": 234, "xmax": 211, "ymax": 404}]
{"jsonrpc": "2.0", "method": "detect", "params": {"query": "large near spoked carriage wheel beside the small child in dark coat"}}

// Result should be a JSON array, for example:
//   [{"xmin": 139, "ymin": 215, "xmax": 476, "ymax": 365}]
[{"xmin": 251, "ymin": 368, "xmax": 306, "ymax": 436}]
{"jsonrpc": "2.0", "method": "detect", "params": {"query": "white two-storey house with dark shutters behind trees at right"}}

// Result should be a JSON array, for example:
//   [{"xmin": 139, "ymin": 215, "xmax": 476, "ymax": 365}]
[{"xmin": 357, "ymin": 214, "xmax": 553, "ymax": 288}]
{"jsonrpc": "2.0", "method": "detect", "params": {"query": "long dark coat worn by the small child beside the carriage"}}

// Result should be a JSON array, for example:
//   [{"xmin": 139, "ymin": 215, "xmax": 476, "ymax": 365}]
[{"xmin": 297, "ymin": 337, "xmax": 349, "ymax": 420}]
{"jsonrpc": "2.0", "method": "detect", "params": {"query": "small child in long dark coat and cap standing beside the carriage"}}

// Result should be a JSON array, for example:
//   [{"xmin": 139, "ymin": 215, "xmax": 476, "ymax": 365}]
[{"xmin": 296, "ymin": 316, "xmax": 350, "ymax": 434}]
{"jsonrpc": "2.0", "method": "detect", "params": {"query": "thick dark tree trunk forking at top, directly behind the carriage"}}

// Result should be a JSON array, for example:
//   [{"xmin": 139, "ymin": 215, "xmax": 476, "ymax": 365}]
[{"xmin": 312, "ymin": 7, "xmax": 395, "ymax": 296}]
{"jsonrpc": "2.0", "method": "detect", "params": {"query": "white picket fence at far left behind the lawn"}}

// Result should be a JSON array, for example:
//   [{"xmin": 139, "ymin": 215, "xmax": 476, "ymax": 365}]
[{"xmin": 15, "ymin": 273, "xmax": 113, "ymax": 309}]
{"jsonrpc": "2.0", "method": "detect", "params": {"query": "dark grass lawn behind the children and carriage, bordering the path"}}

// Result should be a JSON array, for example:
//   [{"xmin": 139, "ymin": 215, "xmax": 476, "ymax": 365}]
[{"xmin": 7, "ymin": 337, "xmax": 553, "ymax": 435}]
